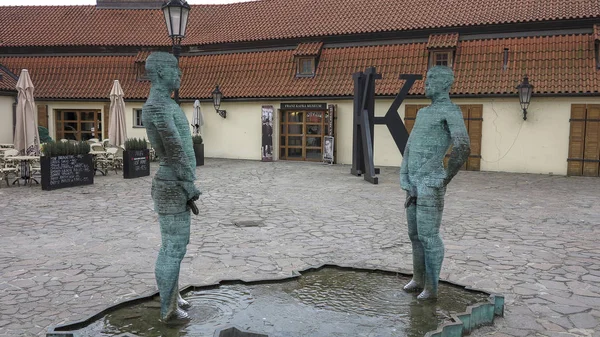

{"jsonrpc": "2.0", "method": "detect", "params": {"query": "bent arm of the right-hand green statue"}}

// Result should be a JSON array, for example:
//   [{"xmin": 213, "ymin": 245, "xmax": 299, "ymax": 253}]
[{"xmin": 445, "ymin": 106, "xmax": 471, "ymax": 184}]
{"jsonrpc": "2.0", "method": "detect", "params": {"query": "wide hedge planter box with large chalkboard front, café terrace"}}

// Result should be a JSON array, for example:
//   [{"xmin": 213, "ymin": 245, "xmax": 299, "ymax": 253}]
[{"xmin": 40, "ymin": 142, "xmax": 94, "ymax": 190}]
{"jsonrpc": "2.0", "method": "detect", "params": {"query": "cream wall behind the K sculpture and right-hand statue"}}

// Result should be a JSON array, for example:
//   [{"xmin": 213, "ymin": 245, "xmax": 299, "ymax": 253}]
[{"xmin": 322, "ymin": 97, "xmax": 600, "ymax": 175}]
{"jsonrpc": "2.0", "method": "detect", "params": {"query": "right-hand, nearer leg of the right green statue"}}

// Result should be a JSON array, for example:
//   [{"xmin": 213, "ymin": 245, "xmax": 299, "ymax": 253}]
[{"xmin": 417, "ymin": 187, "xmax": 445, "ymax": 299}]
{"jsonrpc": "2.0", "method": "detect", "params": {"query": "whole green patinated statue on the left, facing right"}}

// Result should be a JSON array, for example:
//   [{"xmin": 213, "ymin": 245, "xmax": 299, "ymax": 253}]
[{"xmin": 142, "ymin": 52, "xmax": 200, "ymax": 322}]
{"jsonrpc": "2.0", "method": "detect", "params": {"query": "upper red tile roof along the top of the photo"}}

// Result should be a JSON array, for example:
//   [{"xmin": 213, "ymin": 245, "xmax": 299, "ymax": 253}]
[{"xmin": 0, "ymin": 0, "xmax": 600, "ymax": 46}]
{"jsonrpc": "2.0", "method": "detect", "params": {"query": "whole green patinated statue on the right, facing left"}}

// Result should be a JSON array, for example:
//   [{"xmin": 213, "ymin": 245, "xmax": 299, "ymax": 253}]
[{"xmin": 400, "ymin": 66, "xmax": 470, "ymax": 299}]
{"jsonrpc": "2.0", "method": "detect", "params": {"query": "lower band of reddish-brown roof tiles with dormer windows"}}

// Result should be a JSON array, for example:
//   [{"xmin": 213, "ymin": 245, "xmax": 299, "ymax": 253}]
[{"xmin": 0, "ymin": 34, "xmax": 600, "ymax": 99}]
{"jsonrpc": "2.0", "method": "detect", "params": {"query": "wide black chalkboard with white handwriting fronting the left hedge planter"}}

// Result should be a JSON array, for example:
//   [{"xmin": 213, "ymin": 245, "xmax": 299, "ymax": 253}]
[{"xmin": 40, "ymin": 154, "xmax": 94, "ymax": 191}]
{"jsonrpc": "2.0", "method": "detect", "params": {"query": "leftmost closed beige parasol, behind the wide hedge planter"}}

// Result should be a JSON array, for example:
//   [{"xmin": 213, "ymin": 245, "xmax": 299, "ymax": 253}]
[{"xmin": 13, "ymin": 69, "xmax": 40, "ymax": 156}]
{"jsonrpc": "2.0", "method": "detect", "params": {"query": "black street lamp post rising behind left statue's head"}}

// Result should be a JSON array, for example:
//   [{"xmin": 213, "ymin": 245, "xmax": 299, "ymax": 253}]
[{"xmin": 161, "ymin": 0, "xmax": 190, "ymax": 104}]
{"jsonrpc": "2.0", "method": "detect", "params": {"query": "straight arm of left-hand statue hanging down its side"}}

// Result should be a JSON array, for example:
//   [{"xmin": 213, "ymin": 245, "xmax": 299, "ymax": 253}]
[{"xmin": 154, "ymin": 113, "xmax": 200, "ymax": 199}]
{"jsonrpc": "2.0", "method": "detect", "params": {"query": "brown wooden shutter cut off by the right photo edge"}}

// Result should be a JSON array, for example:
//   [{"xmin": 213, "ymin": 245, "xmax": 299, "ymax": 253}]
[{"xmin": 583, "ymin": 105, "xmax": 600, "ymax": 177}]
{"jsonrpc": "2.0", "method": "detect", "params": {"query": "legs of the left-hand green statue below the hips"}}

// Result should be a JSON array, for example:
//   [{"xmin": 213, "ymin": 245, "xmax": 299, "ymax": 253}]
[{"xmin": 155, "ymin": 211, "xmax": 190, "ymax": 321}]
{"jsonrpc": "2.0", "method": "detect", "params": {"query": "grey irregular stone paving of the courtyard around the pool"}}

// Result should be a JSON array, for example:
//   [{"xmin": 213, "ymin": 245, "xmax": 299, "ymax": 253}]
[{"xmin": 0, "ymin": 159, "xmax": 600, "ymax": 337}]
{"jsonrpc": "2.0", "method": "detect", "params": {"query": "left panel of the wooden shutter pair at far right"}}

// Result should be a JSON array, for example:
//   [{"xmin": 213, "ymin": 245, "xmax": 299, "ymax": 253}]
[{"xmin": 567, "ymin": 104, "xmax": 586, "ymax": 176}]
